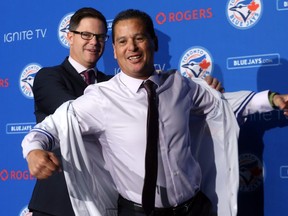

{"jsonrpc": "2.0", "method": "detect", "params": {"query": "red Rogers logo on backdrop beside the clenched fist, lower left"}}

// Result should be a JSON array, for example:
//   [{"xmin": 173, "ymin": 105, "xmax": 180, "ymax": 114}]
[{"xmin": 0, "ymin": 169, "xmax": 36, "ymax": 181}]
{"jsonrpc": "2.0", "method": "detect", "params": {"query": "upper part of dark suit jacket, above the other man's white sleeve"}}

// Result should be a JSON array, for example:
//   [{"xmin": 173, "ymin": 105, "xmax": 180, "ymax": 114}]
[{"xmin": 33, "ymin": 57, "xmax": 111, "ymax": 122}]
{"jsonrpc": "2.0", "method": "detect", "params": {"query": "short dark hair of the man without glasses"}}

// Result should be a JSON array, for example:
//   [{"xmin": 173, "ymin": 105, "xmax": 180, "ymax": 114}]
[{"xmin": 112, "ymin": 9, "xmax": 156, "ymax": 43}]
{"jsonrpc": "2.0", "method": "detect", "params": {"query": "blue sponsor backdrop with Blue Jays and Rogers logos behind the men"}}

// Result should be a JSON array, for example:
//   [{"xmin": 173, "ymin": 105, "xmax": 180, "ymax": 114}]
[{"xmin": 0, "ymin": 0, "xmax": 288, "ymax": 216}]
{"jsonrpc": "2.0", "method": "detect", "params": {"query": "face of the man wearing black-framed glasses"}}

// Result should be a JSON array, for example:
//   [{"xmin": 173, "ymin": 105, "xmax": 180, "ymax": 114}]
[{"xmin": 67, "ymin": 18, "xmax": 106, "ymax": 68}]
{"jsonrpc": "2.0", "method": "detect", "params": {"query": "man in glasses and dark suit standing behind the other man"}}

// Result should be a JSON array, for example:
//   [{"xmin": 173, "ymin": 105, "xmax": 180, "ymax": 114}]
[{"xmin": 28, "ymin": 8, "xmax": 111, "ymax": 216}]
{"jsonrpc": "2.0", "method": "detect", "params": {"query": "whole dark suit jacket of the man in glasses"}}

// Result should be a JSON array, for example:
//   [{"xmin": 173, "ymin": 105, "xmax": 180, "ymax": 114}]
[{"xmin": 28, "ymin": 58, "xmax": 112, "ymax": 216}]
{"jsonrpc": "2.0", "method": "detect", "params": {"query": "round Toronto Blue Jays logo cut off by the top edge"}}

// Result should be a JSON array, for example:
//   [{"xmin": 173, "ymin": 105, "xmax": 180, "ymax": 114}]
[{"xmin": 226, "ymin": 0, "xmax": 263, "ymax": 30}]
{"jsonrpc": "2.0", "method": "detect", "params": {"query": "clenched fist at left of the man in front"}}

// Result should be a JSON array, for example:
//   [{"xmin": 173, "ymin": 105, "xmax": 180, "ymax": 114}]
[{"xmin": 26, "ymin": 149, "xmax": 61, "ymax": 179}]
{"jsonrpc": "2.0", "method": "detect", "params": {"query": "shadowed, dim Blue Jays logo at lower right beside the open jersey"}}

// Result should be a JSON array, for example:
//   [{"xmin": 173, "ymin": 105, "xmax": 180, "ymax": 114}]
[{"xmin": 239, "ymin": 154, "xmax": 263, "ymax": 192}]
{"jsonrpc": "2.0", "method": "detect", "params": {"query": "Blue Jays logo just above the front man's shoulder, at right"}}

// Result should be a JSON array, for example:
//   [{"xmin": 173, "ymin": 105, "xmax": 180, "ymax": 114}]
[{"xmin": 179, "ymin": 47, "xmax": 213, "ymax": 78}]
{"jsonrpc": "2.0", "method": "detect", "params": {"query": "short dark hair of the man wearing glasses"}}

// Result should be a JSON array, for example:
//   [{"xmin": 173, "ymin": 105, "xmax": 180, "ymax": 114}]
[{"xmin": 69, "ymin": 7, "xmax": 108, "ymax": 32}]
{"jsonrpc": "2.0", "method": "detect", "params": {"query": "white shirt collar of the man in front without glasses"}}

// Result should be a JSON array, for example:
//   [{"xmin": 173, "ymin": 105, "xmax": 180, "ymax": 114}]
[{"xmin": 119, "ymin": 71, "xmax": 160, "ymax": 93}]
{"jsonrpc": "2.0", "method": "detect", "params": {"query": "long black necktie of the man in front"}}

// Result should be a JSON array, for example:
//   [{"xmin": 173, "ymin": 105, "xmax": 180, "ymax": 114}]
[{"xmin": 142, "ymin": 80, "xmax": 159, "ymax": 215}]
